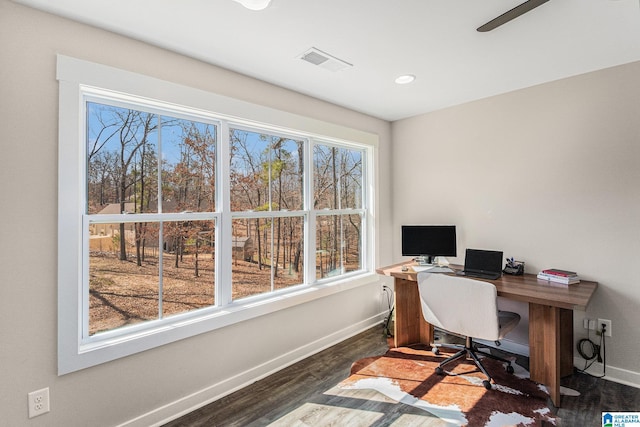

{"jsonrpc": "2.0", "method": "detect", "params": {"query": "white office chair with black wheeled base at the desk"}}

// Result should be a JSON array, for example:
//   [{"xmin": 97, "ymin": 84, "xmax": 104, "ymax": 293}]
[{"xmin": 418, "ymin": 272, "xmax": 520, "ymax": 390}]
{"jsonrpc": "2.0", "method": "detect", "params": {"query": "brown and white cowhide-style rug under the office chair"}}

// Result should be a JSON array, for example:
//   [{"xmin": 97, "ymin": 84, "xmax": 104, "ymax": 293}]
[{"xmin": 339, "ymin": 346, "xmax": 559, "ymax": 427}]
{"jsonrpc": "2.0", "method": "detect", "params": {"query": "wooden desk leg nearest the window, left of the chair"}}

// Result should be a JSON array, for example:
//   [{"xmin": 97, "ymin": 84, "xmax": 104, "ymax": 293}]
[{"xmin": 393, "ymin": 277, "xmax": 433, "ymax": 347}]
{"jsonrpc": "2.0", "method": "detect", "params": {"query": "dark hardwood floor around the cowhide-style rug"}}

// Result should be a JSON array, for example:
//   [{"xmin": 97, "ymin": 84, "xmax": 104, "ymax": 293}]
[{"xmin": 164, "ymin": 327, "xmax": 640, "ymax": 427}]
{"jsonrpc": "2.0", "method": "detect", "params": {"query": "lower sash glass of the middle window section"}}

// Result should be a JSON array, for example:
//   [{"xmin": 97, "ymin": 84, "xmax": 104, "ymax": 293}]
[{"xmin": 232, "ymin": 216, "xmax": 304, "ymax": 300}]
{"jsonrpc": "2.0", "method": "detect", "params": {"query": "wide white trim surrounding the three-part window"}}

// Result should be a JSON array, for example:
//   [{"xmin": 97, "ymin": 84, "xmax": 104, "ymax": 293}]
[{"xmin": 57, "ymin": 55, "xmax": 378, "ymax": 375}]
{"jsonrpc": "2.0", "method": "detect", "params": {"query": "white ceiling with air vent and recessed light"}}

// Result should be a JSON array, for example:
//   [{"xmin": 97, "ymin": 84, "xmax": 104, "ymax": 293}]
[{"xmin": 14, "ymin": 0, "xmax": 640, "ymax": 121}]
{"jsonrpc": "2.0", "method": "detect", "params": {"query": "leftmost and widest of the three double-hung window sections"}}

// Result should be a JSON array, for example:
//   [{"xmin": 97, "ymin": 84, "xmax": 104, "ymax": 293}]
[{"xmin": 83, "ymin": 101, "xmax": 218, "ymax": 339}]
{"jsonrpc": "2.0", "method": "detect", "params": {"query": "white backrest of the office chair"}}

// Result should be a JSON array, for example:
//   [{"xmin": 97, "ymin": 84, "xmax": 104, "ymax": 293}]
[{"xmin": 418, "ymin": 272, "xmax": 500, "ymax": 341}]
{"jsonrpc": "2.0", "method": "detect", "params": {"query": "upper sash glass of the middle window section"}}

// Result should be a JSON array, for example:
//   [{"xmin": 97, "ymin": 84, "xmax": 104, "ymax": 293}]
[{"xmin": 230, "ymin": 129, "xmax": 304, "ymax": 211}]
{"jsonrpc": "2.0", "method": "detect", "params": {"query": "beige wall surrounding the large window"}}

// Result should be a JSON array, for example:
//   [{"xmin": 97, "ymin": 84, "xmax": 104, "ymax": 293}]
[{"xmin": 0, "ymin": 0, "xmax": 391, "ymax": 427}]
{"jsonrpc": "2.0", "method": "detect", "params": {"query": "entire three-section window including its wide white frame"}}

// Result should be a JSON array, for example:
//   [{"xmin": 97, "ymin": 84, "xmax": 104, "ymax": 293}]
[{"xmin": 58, "ymin": 56, "xmax": 375, "ymax": 374}]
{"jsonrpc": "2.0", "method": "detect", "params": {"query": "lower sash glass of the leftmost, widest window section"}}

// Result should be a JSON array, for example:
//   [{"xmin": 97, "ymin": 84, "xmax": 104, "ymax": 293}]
[{"xmin": 89, "ymin": 221, "xmax": 215, "ymax": 335}]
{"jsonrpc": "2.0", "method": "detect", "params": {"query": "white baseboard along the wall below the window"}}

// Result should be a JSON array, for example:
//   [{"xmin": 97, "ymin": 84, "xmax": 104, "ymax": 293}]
[{"xmin": 118, "ymin": 313, "xmax": 385, "ymax": 427}]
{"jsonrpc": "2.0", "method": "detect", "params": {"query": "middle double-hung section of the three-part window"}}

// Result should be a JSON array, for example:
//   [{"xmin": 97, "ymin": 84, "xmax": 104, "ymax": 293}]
[{"xmin": 229, "ymin": 128, "xmax": 308, "ymax": 300}]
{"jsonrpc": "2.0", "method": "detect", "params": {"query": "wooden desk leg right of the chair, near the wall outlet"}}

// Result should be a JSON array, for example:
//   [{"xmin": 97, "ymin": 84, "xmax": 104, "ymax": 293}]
[{"xmin": 529, "ymin": 303, "xmax": 573, "ymax": 407}]
